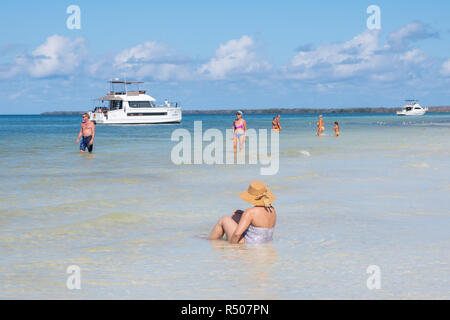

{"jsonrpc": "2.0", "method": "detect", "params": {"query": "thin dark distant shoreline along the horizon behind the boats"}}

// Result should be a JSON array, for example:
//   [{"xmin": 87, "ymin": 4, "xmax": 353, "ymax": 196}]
[{"xmin": 41, "ymin": 106, "xmax": 450, "ymax": 116}]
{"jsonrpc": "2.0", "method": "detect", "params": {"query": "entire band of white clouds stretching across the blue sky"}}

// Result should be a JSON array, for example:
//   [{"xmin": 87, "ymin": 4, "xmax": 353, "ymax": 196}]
[{"xmin": 0, "ymin": 22, "xmax": 450, "ymax": 97}]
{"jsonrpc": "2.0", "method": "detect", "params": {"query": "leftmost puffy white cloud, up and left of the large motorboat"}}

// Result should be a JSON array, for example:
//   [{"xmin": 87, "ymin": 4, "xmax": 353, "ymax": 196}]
[{"xmin": 28, "ymin": 35, "xmax": 87, "ymax": 78}]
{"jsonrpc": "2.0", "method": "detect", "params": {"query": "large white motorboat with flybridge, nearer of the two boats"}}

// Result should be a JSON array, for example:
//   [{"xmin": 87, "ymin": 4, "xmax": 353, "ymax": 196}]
[{"xmin": 88, "ymin": 79, "xmax": 182, "ymax": 124}]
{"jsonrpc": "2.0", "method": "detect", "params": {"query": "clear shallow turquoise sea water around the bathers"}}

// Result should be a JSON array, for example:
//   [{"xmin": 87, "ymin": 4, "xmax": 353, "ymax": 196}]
[{"xmin": 0, "ymin": 114, "xmax": 450, "ymax": 299}]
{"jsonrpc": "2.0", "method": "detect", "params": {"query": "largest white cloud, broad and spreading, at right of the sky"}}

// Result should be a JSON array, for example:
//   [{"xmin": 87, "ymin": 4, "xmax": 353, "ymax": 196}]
[{"xmin": 284, "ymin": 23, "xmax": 435, "ymax": 82}]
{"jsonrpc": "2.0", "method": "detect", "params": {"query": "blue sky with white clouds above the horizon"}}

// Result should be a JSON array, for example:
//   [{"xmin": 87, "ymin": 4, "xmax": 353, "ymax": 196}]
[{"xmin": 0, "ymin": 0, "xmax": 450, "ymax": 114}]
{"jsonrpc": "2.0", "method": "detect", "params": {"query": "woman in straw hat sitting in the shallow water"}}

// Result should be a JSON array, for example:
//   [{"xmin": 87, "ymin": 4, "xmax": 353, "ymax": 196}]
[{"xmin": 209, "ymin": 181, "xmax": 277, "ymax": 244}]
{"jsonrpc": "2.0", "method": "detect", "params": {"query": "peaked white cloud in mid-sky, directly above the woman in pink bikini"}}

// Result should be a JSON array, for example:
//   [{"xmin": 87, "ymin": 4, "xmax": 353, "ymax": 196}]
[{"xmin": 198, "ymin": 35, "xmax": 271, "ymax": 79}]
